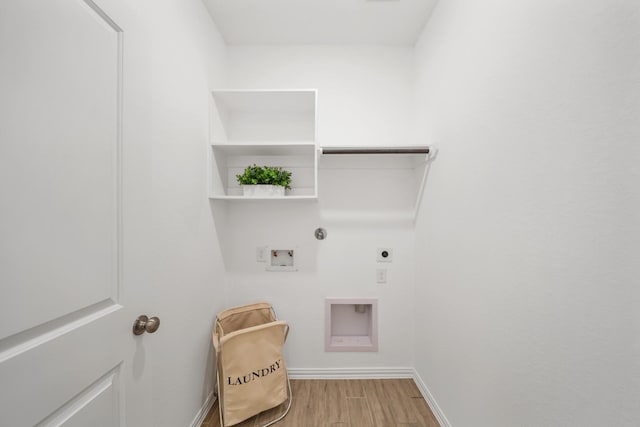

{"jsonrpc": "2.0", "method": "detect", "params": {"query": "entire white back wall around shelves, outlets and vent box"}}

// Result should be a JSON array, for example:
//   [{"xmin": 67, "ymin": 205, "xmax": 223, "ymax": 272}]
[{"xmin": 214, "ymin": 46, "xmax": 414, "ymax": 369}]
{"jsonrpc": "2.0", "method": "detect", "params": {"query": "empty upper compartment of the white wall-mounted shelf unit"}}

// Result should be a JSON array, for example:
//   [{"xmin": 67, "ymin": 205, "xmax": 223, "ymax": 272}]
[{"xmin": 211, "ymin": 89, "xmax": 317, "ymax": 144}]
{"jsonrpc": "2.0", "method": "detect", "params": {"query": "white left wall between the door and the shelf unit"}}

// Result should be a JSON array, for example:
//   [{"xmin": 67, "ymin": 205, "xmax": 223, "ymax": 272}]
[{"xmin": 146, "ymin": 0, "xmax": 226, "ymax": 427}]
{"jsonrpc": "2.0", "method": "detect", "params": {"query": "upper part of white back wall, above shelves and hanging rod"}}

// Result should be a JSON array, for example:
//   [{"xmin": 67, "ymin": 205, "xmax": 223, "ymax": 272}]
[{"xmin": 228, "ymin": 46, "xmax": 413, "ymax": 145}]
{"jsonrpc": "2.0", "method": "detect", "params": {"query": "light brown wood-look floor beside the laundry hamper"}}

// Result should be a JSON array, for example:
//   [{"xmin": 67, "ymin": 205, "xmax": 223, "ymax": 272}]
[{"xmin": 201, "ymin": 379, "xmax": 440, "ymax": 427}]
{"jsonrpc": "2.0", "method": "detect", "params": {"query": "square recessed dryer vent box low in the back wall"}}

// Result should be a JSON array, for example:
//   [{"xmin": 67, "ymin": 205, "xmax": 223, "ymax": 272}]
[{"xmin": 325, "ymin": 298, "xmax": 378, "ymax": 352}]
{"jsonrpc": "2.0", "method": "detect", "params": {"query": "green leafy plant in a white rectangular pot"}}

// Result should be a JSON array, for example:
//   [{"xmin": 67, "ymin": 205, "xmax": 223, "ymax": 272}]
[{"xmin": 236, "ymin": 164, "xmax": 291, "ymax": 197}]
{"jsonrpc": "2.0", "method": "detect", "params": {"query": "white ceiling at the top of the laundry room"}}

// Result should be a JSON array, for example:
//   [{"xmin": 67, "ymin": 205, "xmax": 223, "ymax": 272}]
[{"xmin": 203, "ymin": 0, "xmax": 438, "ymax": 46}]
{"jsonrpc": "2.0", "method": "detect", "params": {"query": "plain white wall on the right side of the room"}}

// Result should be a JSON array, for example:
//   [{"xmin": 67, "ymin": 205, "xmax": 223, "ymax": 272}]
[{"xmin": 416, "ymin": 0, "xmax": 640, "ymax": 427}]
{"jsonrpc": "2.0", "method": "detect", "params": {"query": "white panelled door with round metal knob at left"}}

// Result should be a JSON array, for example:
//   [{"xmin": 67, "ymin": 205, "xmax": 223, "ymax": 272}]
[{"xmin": 0, "ymin": 0, "xmax": 154, "ymax": 427}]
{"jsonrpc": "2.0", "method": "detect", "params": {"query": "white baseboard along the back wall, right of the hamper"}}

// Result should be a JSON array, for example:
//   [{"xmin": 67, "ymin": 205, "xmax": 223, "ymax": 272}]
[{"xmin": 287, "ymin": 368, "xmax": 415, "ymax": 380}]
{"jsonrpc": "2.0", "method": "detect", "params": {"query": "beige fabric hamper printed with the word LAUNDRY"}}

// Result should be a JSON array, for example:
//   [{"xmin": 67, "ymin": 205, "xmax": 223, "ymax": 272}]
[{"xmin": 213, "ymin": 303, "xmax": 291, "ymax": 427}]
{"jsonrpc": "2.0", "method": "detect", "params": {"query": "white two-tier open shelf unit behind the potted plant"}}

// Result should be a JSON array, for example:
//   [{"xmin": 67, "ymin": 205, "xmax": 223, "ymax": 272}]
[{"xmin": 209, "ymin": 89, "xmax": 318, "ymax": 200}]
